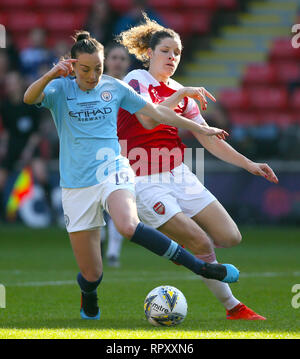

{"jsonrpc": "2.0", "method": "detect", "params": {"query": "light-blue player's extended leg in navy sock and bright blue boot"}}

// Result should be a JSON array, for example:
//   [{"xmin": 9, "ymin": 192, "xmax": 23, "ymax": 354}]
[{"xmin": 107, "ymin": 189, "xmax": 239, "ymax": 282}]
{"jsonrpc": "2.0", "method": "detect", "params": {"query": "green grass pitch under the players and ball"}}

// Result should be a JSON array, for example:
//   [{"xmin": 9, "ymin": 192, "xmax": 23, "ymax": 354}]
[{"xmin": 0, "ymin": 226, "xmax": 300, "ymax": 339}]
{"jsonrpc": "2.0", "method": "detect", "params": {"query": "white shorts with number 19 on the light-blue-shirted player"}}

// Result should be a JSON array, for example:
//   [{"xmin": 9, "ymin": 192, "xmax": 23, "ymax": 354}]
[{"xmin": 62, "ymin": 167, "xmax": 135, "ymax": 233}]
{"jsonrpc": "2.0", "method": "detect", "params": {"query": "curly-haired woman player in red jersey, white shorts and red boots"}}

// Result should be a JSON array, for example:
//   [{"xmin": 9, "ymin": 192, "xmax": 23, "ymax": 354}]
[{"xmin": 118, "ymin": 14, "xmax": 278, "ymax": 320}]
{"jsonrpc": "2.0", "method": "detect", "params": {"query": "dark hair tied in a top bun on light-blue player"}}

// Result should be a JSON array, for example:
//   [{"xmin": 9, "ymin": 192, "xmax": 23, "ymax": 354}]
[{"xmin": 71, "ymin": 30, "xmax": 104, "ymax": 59}]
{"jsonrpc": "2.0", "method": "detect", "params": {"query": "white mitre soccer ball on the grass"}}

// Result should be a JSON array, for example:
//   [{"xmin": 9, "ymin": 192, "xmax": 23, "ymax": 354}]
[{"xmin": 144, "ymin": 285, "xmax": 187, "ymax": 327}]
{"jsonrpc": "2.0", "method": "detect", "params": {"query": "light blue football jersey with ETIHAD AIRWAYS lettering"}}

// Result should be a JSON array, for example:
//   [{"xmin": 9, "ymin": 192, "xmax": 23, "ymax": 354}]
[{"xmin": 38, "ymin": 75, "xmax": 146, "ymax": 188}]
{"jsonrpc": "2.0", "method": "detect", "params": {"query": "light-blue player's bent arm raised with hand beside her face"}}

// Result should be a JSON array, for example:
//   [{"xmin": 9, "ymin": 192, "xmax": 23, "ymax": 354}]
[{"xmin": 23, "ymin": 59, "xmax": 78, "ymax": 105}]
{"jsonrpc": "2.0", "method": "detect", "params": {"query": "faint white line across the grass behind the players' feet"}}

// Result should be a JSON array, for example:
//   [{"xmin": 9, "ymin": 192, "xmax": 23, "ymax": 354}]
[{"xmin": 6, "ymin": 272, "xmax": 300, "ymax": 287}]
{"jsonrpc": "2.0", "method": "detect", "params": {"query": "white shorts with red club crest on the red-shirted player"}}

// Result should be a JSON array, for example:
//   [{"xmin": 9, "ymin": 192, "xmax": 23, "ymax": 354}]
[{"xmin": 135, "ymin": 164, "xmax": 216, "ymax": 228}]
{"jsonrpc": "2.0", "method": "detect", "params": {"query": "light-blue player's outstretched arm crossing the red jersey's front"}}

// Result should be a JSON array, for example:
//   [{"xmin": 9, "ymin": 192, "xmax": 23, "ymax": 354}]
[{"xmin": 136, "ymin": 102, "xmax": 228, "ymax": 139}]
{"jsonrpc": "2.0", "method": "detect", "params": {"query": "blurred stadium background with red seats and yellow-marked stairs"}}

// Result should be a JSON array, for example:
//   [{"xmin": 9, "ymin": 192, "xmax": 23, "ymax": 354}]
[{"xmin": 0, "ymin": 0, "xmax": 300, "ymax": 227}]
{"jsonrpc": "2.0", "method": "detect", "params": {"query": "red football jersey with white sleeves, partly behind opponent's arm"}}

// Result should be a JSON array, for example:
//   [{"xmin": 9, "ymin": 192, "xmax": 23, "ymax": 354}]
[{"xmin": 118, "ymin": 70, "xmax": 204, "ymax": 176}]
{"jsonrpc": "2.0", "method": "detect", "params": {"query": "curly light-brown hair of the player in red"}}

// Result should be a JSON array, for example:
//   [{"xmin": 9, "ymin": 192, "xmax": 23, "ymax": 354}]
[{"xmin": 116, "ymin": 12, "xmax": 180, "ymax": 67}]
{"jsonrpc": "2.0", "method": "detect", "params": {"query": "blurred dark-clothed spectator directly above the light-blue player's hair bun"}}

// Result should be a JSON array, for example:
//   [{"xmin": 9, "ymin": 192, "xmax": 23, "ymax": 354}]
[{"xmin": 84, "ymin": 0, "xmax": 119, "ymax": 46}]
